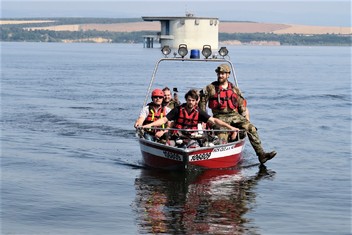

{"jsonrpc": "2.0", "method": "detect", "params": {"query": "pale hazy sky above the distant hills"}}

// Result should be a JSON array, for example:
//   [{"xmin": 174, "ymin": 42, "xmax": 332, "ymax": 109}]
[{"xmin": 1, "ymin": 0, "xmax": 351, "ymax": 26}]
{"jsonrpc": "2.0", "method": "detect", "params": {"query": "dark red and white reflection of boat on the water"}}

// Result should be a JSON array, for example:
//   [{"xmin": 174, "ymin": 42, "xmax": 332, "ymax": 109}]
[{"xmin": 134, "ymin": 166, "xmax": 275, "ymax": 234}]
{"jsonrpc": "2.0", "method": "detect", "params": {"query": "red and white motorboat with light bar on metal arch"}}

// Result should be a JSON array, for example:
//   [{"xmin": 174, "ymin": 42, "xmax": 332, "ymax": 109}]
[{"xmin": 137, "ymin": 44, "xmax": 246, "ymax": 170}]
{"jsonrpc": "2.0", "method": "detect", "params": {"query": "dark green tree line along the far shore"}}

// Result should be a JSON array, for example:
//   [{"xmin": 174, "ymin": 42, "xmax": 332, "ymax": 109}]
[{"xmin": 0, "ymin": 18, "xmax": 352, "ymax": 46}]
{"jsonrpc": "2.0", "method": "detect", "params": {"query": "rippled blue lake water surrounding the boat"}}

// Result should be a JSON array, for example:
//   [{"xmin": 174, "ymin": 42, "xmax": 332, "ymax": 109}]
[{"xmin": 1, "ymin": 43, "xmax": 351, "ymax": 235}]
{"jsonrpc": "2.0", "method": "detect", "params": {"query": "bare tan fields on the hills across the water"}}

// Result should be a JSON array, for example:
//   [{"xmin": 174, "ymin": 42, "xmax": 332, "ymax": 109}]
[{"xmin": 0, "ymin": 18, "xmax": 352, "ymax": 35}]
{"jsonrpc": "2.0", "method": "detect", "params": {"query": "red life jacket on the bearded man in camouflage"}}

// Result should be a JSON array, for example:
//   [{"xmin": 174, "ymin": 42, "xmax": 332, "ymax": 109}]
[{"xmin": 208, "ymin": 82, "xmax": 238, "ymax": 111}]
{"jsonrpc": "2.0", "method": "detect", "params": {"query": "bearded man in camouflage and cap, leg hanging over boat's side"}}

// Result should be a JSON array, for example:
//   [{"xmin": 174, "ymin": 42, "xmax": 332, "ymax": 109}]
[{"xmin": 199, "ymin": 64, "xmax": 276, "ymax": 164}]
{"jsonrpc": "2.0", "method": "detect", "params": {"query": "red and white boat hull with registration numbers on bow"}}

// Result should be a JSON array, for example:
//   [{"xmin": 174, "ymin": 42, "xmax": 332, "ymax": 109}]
[{"xmin": 139, "ymin": 139, "xmax": 245, "ymax": 170}]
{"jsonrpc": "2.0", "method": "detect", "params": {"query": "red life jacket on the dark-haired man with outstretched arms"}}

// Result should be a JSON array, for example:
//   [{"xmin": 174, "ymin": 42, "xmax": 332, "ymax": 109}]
[{"xmin": 175, "ymin": 104, "xmax": 199, "ymax": 130}]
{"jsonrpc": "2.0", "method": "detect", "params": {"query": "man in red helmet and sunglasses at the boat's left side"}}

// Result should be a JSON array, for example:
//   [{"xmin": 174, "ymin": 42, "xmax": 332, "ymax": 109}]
[{"xmin": 134, "ymin": 89, "xmax": 171, "ymax": 141}]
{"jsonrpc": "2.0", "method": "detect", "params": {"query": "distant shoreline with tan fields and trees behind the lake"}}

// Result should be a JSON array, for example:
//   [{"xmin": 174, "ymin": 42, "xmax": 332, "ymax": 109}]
[{"xmin": 0, "ymin": 18, "xmax": 352, "ymax": 46}]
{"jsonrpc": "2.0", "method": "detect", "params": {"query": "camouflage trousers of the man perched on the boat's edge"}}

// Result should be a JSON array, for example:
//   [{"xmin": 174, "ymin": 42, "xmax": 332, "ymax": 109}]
[{"xmin": 214, "ymin": 113, "xmax": 264, "ymax": 156}]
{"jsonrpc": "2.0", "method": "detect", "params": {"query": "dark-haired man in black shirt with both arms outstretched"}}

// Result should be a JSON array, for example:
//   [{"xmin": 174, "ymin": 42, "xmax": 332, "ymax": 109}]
[{"xmin": 143, "ymin": 90, "xmax": 238, "ymax": 138}]
